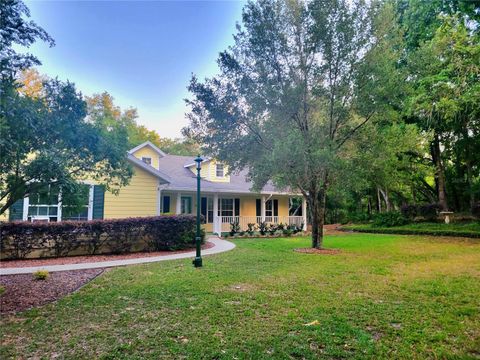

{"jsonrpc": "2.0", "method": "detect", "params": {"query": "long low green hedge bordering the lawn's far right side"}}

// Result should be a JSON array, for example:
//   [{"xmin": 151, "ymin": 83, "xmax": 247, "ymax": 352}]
[{"xmin": 342, "ymin": 222, "xmax": 480, "ymax": 238}]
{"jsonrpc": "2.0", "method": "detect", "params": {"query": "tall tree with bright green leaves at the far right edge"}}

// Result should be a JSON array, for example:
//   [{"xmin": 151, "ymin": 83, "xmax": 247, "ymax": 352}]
[{"xmin": 408, "ymin": 9, "xmax": 480, "ymax": 209}]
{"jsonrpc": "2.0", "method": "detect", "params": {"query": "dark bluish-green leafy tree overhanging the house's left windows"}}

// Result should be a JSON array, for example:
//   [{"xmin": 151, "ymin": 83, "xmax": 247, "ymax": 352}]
[{"xmin": 0, "ymin": 80, "xmax": 132, "ymax": 214}]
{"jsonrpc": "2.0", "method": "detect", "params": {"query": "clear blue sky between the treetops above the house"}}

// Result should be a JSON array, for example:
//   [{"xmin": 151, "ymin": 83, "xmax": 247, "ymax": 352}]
[{"xmin": 20, "ymin": 0, "xmax": 244, "ymax": 138}]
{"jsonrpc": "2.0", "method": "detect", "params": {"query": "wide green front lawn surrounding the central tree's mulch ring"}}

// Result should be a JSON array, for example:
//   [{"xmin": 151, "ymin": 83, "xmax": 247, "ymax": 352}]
[{"xmin": 0, "ymin": 234, "xmax": 480, "ymax": 359}]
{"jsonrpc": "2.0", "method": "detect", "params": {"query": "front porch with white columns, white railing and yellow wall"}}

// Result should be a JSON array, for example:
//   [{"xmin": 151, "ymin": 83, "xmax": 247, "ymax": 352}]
[{"xmin": 159, "ymin": 189, "xmax": 307, "ymax": 234}]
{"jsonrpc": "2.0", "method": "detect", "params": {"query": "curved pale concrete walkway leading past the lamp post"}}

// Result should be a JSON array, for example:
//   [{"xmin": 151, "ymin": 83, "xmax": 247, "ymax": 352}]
[{"xmin": 0, "ymin": 236, "xmax": 235, "ymax": 275}]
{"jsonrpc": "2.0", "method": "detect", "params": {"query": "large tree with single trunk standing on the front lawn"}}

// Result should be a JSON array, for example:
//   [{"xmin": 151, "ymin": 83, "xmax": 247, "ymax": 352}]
[{"xmin": 184, "ymin": 0, "xmax": 404, "ymax": 248}]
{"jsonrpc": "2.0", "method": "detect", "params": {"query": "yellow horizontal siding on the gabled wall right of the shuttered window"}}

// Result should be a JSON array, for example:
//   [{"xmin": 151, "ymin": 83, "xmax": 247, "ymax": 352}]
[{"xmin": 104, "ymin": 166, "xmax": 158, "ymax": 219}]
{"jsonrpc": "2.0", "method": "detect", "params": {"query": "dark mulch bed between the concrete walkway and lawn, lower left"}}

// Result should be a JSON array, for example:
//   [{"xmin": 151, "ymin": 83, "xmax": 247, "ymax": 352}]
[{"xmin": 0, "ymin": 269, "xmax": 103, "ymax": 314}]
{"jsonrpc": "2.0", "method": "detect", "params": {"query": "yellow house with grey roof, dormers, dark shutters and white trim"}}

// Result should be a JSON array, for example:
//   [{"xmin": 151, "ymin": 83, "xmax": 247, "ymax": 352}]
[{"xmin": 9, "ymin": 141, "xmax": 307, "ymax": 233}]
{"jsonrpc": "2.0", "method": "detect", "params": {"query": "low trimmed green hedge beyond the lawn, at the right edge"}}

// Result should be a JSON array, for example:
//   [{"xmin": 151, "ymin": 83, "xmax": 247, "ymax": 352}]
[{"xmin": 341, "ymin": 226, "xmax": 480, "ymax": 239}]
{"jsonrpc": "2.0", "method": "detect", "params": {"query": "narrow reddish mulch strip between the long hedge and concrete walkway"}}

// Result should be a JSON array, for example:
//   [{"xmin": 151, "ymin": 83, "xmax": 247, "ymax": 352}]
[{"xmin": 0, "ymin": 241, "xmax": 215, "ymax": 268}]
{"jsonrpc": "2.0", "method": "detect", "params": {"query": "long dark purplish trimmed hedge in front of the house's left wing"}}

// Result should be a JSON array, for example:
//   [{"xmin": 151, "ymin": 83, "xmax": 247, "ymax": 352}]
[{"xmin": 0, "ymin": 215, "xmax": 205, "ymax": 259}]
